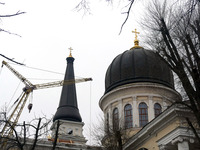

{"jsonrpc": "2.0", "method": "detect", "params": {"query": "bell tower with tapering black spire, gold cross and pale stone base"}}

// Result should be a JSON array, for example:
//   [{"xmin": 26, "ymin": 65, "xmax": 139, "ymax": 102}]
[{"xmin": 51, "ymin": 48, "xmax": 86, "ymax": 144}]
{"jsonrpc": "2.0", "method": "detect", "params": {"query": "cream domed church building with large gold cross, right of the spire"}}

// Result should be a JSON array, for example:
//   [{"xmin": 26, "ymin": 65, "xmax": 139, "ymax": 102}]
[{"xmin": 99, "ymin": 30, "xmax": 200, "ymax": 150}]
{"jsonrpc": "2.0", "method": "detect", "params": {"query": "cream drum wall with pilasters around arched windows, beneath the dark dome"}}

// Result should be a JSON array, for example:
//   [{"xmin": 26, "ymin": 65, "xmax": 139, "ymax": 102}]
[{"xmin": 99, "ymin": 83, "xmax": 181, "ymax": 128}]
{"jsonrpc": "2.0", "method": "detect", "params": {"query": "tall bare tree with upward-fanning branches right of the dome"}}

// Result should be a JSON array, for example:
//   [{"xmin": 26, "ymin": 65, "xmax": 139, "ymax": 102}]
[{"xmin": 142, "ymin": 0, "xmax": 200, "ymax": 142}]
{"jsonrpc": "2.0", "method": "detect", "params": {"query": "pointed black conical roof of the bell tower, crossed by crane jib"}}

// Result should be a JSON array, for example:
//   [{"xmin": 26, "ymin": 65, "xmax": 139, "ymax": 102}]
[{"xmin": 53, "ymin": 57, "xmax": 82, "ymax": 122}]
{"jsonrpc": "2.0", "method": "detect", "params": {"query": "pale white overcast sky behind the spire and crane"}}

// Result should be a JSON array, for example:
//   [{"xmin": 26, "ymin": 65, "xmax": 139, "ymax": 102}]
[{"xmin": 0, "ymin": 0, "xmax": 145, "ymax": 144}]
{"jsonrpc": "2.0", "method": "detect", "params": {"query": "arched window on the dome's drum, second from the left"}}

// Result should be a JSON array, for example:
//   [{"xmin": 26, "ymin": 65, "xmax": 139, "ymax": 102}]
[{"xmin": 124, "ymin": 104, "xmax": 133, "ymax": 129}]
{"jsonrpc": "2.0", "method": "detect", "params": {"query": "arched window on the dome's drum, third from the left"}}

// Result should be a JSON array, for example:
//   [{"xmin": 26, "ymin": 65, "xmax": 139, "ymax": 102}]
[{"xmin": 139, "ymin": 102, "xmax": 148, "ymax": 127}]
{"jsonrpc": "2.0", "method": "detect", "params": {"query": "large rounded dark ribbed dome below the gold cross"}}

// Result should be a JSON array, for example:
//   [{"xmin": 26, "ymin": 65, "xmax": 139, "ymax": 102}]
[{"xmin": 105, "ymin": 48, "xmax": 174, "ymax": 93}]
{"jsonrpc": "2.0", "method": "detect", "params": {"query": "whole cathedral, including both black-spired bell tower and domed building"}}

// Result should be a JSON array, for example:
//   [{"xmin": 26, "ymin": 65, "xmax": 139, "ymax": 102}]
[{"xmin": 1, "ymin": 31, "xmax": 200, "ymax": 150}]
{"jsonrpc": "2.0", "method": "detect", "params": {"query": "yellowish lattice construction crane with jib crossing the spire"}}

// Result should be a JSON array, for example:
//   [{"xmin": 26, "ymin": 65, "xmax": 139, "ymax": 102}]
[{"xmin": 1, "ymin": 61, "xmax": 92, "ymax": 137}]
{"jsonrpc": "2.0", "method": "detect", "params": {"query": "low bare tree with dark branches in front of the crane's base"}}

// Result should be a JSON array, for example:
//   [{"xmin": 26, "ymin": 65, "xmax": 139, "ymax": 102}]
[{"xmin": 0, "ymin": 113, "xmax": 51, "ymax": 150}]
